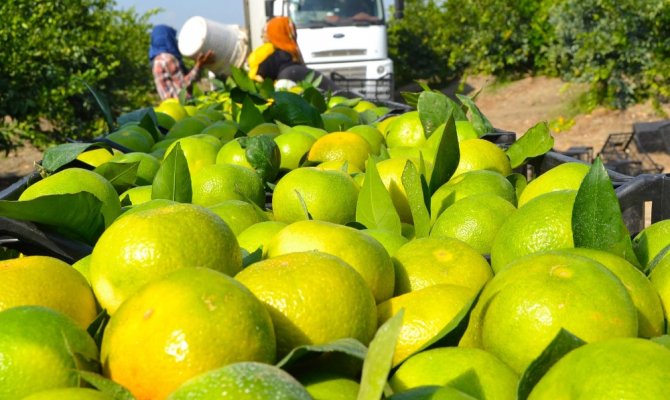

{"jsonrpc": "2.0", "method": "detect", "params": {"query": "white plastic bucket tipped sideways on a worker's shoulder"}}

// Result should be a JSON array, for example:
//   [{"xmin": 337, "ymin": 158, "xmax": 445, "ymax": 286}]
[{"xmin": 177, "ymin": 17, "xmax": 249, "ymax": 75}]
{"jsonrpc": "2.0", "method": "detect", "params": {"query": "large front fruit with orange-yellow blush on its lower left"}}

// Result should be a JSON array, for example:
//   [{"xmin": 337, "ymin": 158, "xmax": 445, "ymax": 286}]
[{"xmin": 100, "ymin": 267, "xmax": 276, "ymax": 399}]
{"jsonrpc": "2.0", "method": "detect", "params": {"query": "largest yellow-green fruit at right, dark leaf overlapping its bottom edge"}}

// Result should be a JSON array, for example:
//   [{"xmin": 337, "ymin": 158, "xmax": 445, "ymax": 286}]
[{"xmin": 460, "ymin": 252, "xmax": 638, "ymax": 374}]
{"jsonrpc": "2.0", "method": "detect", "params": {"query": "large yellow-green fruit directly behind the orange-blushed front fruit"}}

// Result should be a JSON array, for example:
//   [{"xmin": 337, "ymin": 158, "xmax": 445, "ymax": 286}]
[{"xmin": 90, "ymin": 203, "xmax": 242, "ymax": 315}]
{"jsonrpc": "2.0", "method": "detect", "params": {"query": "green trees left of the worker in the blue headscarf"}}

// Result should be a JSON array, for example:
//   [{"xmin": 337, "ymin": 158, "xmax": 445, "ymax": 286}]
[{"xmin": 0, "ymin": 0, "xmax": 153, "ymax": 148}]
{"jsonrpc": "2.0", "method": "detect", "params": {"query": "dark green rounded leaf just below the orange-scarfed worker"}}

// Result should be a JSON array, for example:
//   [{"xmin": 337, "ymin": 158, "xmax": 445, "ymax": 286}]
[{"xmin": 263, "ymin": 92, "xmax": 323, "ymax": 128}]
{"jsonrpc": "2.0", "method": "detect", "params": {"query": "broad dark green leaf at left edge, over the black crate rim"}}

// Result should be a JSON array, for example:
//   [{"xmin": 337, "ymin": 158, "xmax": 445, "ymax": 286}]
[{"xmin": 0, "ymin": 192, "xmax": 105, "ymax": 245}]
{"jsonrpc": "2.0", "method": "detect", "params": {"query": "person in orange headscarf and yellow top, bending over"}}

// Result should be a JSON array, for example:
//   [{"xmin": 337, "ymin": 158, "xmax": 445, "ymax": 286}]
[{"xmin": 247, "ymin": 17, "xmax": 337, "ymax": 90}]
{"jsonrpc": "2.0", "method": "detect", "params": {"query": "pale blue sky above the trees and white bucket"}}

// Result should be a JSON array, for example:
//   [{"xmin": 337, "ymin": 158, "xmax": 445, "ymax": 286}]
[{"xmin": 116, "ymin": 0, "xmax": 393, "ymax": 30}]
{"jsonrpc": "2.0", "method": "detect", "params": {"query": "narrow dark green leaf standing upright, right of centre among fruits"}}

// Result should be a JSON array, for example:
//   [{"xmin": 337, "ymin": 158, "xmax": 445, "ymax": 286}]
[{"xmin": 428, "ymin": 114, "xmax": 460, "ymax": 196}]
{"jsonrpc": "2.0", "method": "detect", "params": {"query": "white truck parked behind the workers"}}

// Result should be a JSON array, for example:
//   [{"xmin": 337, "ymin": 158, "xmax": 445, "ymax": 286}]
[{"xmin": 244, "ymin": 0, "xmax": 403, "ymax": 100}]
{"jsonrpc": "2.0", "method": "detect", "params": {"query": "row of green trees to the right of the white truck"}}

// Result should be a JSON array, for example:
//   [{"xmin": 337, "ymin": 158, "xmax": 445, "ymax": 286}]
[{"xmin": 389, "ymin": 0, "xmax": 670, "ymax": 108}]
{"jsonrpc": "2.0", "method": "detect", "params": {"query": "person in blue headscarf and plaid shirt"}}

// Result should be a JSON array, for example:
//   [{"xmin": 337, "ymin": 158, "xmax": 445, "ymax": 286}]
[{"xmin": 149, "ymin": 25, "xmax": 214, "ymax": 100}]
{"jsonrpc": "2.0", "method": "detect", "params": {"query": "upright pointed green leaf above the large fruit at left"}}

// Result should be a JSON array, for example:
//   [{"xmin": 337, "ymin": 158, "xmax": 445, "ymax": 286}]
[{"xmin": 151, "ymin": 142, "xmax": 192, "ymax": 203}]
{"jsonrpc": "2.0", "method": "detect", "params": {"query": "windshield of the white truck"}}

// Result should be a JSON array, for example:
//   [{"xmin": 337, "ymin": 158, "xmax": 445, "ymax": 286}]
[{"xmin": 288, "ymin": 0, "xmax": 384, "ymax": 28}]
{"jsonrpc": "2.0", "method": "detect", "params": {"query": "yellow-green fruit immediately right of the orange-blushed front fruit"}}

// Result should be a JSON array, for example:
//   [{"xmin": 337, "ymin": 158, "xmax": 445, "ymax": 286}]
[{"xmin": 235, "ymin": 252, "xmax": 377, "ymax": 357}]
